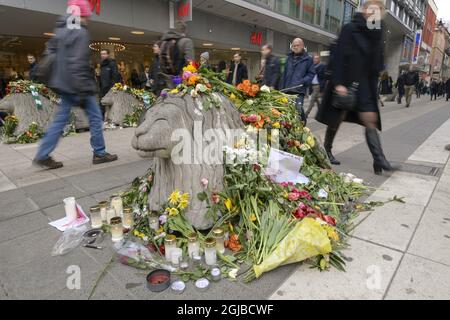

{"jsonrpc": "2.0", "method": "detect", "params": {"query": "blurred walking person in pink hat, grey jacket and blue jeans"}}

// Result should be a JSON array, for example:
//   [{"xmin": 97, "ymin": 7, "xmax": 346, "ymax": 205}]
[{"xmin": 33, "ymin": 0, "xmax": 117, "ymax": 169}]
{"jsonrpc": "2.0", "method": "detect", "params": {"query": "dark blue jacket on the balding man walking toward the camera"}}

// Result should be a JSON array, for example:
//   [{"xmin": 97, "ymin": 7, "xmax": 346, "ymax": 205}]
[{"xmin": 281, "ymin": 52, "xmax": 316, "ymax": 94}]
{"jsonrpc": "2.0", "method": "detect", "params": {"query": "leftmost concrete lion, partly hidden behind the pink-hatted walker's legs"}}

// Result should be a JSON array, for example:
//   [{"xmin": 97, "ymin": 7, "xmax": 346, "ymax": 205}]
[{"xmin": 0, "ymin": 93, "xmax": 89, "ymax": 135}]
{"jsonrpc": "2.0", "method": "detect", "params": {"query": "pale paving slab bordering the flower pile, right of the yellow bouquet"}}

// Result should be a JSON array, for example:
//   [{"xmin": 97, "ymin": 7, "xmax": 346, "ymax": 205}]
[{"xmin": 353, "ymin": 202, "xmax": 424, "ymax": 251}]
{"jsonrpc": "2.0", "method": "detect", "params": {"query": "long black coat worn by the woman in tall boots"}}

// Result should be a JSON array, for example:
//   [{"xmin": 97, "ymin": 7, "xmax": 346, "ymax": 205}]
[{"xmin": 316, "ymin": 13, "xmax": 384, "ymax": 130}]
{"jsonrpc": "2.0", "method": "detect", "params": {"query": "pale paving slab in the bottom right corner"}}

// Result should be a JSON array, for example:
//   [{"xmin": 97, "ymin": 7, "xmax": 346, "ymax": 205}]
[{"xmin": 386, "ymin": 254, "xmax": 450, "ymax": 300}]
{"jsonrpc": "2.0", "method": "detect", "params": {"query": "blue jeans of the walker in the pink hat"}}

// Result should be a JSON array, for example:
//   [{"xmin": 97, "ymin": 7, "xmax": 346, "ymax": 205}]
[{"xmin": 35, "ymin": 93, "xmax": 106, "ymax": 161}]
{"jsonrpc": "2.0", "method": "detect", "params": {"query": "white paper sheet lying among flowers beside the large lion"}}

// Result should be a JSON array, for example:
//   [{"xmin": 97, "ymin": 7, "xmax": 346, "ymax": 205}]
[{"xmin": 265, "ymin": 148, "xmax": 309, "ymax": 184}]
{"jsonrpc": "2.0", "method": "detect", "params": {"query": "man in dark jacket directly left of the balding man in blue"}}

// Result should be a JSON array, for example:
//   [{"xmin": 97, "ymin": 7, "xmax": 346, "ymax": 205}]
[{"xmin": 257, "ymin": 44, "xmax": 281, "ymax": 90}]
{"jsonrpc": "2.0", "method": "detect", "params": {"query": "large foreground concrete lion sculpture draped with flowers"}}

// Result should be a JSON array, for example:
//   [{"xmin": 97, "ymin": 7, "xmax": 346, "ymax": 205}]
[{"xmin": 132, "ymin": 95, "xmax": 244, "ymax": 230}]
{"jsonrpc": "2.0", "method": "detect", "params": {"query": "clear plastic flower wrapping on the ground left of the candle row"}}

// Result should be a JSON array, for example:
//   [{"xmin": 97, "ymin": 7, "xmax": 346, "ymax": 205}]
[{"xmin": 115, "ymin": 241, "xmax": 176, "ymax": 272}]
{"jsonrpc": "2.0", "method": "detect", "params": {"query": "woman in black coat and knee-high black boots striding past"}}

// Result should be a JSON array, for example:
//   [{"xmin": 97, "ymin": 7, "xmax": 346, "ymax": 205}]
[{"xmin": 316, "ymin": 0, "xmax": 394, "ymax": 175}]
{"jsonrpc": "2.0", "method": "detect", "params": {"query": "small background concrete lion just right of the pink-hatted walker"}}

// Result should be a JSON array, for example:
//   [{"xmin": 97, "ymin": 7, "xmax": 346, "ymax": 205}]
[{"xmin": 101, "ymin": 88, "xmax": 141, "ymax": 126}]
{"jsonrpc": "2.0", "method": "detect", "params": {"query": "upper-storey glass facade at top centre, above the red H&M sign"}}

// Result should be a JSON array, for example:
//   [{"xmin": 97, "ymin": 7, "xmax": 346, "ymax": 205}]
[{"xmin": 246, "ymin": 0, "xmax": 344, "ymax": 33}]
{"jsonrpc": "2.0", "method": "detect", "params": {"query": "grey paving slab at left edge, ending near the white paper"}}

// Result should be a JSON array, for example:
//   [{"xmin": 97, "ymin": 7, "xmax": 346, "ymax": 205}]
[{"xmin": 0, "ymin": 211, "xmax": 49, "ymax": 242}]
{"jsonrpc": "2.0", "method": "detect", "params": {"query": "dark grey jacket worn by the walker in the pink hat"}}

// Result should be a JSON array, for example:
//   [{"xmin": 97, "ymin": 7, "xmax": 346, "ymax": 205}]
[{"xmin": 47, "ymin": 17, "xmax": 97, "ymax": 95}]
